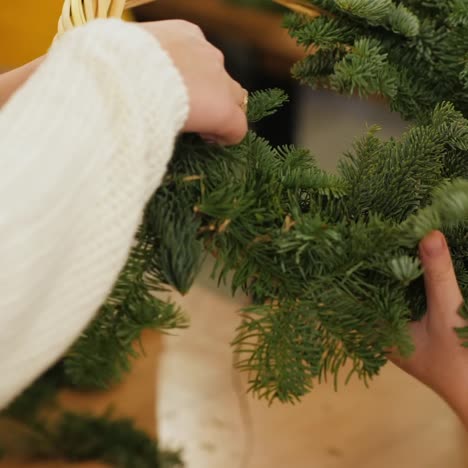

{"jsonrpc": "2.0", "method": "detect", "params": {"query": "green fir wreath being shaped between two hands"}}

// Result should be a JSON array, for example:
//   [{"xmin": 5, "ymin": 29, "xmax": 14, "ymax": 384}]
[{"xmin": 0, "ymin": 0, "xmax": 468, "ymax": 468}]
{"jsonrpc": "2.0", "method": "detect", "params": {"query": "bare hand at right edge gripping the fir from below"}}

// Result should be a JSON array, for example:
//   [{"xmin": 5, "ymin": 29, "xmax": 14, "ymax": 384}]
[{"xmin": 392, "ymin": 232, "xmax": 468, "ymax": 427}]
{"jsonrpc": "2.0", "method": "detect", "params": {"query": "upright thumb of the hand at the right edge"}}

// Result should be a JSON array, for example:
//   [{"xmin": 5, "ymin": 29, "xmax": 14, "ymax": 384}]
[{"xmin": 419, "ymin": 231, "xmax": 463, "ymax": 314}]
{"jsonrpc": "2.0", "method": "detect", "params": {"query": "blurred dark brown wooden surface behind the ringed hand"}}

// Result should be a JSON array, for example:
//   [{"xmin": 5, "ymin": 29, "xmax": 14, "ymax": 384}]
[{"xmin": 135, "ymin": 0, "xmax": 304, "ymax": 74}]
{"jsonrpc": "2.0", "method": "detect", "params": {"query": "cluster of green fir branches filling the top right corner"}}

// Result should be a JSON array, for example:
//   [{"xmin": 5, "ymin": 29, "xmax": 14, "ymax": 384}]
[{"xmin": 286, "ymin": 0, "xmax": 468, "ymax": 120}]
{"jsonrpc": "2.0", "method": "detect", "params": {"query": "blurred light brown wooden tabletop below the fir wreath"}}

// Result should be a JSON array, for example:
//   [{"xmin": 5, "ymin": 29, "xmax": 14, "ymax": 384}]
[{"xmin": 154, "ymin": 262, "xmax": 468, "ymax": 468}]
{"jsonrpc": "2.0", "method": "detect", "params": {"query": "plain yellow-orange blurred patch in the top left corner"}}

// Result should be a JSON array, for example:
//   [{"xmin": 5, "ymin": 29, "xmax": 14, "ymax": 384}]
[{"xmin": 0, "ymin": 0, "xmax": 132, "ymax": 70}]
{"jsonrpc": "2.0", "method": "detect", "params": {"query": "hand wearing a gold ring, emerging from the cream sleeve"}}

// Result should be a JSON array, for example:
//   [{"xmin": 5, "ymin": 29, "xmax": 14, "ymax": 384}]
[{"xmin": 142, "ymin": 20, "xmax": 247, "ymax": 144}]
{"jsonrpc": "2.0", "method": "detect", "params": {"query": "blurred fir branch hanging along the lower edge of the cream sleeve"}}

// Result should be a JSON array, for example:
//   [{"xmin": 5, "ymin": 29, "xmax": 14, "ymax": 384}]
[{"xmin": 64, "ymin": 239, "xmax": 187, "ymax": 389}]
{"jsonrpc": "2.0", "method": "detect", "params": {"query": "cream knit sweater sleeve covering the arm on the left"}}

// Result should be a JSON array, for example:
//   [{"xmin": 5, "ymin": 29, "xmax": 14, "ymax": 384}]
[{"xmin": 0, "ymin": 20, "xmax": 188, "ymax": 407}]
